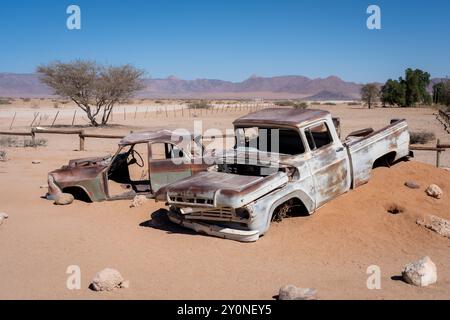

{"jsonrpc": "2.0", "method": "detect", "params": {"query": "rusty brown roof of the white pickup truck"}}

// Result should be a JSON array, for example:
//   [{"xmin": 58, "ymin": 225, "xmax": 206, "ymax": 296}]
[{"xmin": 233, "ymin": 108, "xmax": 330, "ymax": 127}]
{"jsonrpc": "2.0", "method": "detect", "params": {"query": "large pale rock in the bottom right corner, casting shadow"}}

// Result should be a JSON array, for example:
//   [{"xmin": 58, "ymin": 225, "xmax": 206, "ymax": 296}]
[{"xmin": 402, "ymin": 256, "xmax": 437, "ymax": 287}]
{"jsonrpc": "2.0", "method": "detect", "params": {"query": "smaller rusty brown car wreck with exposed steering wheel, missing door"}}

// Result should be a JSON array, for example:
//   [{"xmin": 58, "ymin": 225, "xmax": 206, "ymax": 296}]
[{"xmin": 47, "ymin": 130, "xmax": 208, "ymax": 201}]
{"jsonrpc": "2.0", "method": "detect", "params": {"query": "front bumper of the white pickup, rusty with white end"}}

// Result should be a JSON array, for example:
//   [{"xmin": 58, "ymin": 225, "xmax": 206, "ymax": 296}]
[{"xmin": 167, "ymin": 211, "xmax": 259, "ymax": 242}]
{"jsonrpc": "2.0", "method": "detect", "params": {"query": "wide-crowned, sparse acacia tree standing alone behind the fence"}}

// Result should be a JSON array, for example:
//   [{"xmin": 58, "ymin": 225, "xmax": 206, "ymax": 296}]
[{"xmin": 37, "ymin": 60, "xmax": 143, "ymax": 126}]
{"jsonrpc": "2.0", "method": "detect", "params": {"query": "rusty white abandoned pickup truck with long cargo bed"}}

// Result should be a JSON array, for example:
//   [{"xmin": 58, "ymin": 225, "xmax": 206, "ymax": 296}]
[{"xmin": 156, "ymin": 109, "xmax": 410, "ymax": 242}]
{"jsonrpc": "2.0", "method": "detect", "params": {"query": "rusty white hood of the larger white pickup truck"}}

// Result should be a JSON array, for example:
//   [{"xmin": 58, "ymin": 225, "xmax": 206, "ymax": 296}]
[{"xmin": 156, "ymin": 171, "xmax": 289, "ymax": 208}]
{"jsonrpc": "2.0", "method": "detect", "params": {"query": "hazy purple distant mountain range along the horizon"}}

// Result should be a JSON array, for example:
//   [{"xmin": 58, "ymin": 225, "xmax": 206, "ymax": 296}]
[{"xmin": 0, "ymin": 73, "xmax": 444, "ymax": 100}]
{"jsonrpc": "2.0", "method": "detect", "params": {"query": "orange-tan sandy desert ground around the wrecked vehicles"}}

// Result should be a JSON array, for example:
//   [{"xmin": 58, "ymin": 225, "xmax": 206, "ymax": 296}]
[{"xmin": 0, "ymin": 102, "xmax": 450, "ymax": 299}]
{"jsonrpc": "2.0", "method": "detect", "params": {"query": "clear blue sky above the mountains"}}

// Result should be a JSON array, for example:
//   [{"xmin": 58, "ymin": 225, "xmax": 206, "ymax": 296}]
[{"xmin": 0, "ymin": 0, "xmax": 450, "ymax": 82}]
